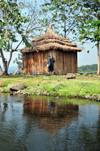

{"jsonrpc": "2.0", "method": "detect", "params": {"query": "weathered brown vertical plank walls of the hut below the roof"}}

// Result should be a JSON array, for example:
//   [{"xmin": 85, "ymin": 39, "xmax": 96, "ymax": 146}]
[{"xmin": 23, "ymin": 50, "xmax": 77, "ymax": 75}]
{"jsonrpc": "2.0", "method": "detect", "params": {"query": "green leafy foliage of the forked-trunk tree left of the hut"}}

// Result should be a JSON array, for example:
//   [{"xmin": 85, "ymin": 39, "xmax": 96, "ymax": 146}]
[{"xmin": 0, "ymin": 0, "xmax": 31, "ymax": 51}]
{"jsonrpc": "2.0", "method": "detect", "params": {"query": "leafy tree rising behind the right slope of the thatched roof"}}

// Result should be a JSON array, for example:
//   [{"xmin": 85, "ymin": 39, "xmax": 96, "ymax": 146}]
[{"xmin": 42, "ymin": 0, "xmax": 81, "ymax": 41}]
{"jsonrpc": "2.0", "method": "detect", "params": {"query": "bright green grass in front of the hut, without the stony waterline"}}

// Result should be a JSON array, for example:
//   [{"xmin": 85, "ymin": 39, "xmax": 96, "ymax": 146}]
[{"xmin": 0, "ymin": 74, "xmax": 100, "ymax": 96}]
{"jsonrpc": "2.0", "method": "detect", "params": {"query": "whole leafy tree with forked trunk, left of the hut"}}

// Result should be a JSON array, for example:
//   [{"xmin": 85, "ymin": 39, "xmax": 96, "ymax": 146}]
[{"xmin": 0, "ymin": 0, "xmax": 31, "ymax": 75}]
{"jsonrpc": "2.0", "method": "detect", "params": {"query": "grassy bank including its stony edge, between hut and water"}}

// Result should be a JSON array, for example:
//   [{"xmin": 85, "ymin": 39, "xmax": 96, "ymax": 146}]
[{"xmin": 0, "ymin": 74, "xmax": 100, "ymax": 102}]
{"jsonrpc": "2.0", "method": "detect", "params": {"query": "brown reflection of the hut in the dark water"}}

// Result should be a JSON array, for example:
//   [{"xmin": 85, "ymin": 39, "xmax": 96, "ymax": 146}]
[{"xmin": 24, "ymin": 97, "xmax": 79, "ymax": 133}]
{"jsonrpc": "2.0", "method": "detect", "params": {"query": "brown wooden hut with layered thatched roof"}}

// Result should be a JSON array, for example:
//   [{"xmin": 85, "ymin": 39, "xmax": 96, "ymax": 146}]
[{"xmin": 20, "ymin": 24, "xmax": 82, "ymax": 75}]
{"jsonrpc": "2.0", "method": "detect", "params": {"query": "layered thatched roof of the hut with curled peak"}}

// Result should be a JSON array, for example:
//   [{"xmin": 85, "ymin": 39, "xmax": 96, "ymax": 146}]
[{"xmin": 20, "ymin": 24, "xmax": 82, "ymax": 53}]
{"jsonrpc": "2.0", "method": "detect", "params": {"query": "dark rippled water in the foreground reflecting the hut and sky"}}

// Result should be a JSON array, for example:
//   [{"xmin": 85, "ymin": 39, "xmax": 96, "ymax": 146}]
[{"xmin": 0, "ymin": 95, "xmax": 100, "ymax": 151}]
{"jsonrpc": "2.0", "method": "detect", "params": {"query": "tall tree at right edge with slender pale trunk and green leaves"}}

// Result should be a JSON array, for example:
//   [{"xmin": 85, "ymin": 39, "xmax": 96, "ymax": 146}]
[{"xmin": 77, "ymin": 0, "xmax": 100, "ymax": 75}]
